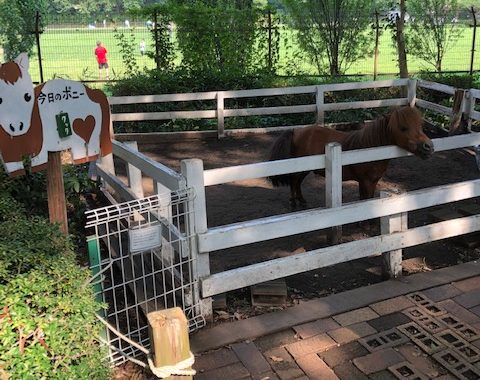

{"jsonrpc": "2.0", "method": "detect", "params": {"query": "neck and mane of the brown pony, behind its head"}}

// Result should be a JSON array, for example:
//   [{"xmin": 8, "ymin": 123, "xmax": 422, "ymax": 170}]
[{"xmin": 342, "ymin": 114, "xmax": 392, "ymax": 150}]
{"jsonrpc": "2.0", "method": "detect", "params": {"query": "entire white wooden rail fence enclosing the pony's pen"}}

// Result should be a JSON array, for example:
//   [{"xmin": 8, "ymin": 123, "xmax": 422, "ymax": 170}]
[{"xmin": 100, "ymin": 79, "xmax": 480, "ymax": 315}]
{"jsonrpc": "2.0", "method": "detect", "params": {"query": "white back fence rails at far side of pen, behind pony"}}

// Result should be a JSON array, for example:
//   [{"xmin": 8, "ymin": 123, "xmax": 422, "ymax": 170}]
[{"xmin": 109, "ymin": 79, "xmax": 416, "ymax": 137}]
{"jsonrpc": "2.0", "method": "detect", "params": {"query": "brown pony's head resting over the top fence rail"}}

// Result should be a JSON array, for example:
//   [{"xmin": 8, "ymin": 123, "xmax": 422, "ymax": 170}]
[{"xmin": 388, "ymin": 106, "xmax": 434, "ymax": 159}]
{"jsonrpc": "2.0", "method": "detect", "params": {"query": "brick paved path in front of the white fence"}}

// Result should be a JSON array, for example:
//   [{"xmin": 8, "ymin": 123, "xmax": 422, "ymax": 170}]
[{"xmin": 191, "ymin": 262, "xmax": 480, "ymax": 380}]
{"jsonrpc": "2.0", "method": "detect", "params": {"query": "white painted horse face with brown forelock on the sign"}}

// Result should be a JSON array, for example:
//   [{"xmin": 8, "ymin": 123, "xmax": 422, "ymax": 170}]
[{"xmin": 0, "ymin": 53, "xmax": 35, "ymax": 136}]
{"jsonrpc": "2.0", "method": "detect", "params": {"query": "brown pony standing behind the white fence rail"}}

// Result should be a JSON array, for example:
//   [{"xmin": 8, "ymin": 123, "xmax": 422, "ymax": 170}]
[{"xmin": 269, "ymin": 106, "xmax": 433, "ymax": 206}]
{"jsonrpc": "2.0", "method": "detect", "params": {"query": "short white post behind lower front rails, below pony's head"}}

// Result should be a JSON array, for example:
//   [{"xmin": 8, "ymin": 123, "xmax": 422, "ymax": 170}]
[{"xmin": 380, "ymin": 191, "xmax": 408, "ymax": 278}]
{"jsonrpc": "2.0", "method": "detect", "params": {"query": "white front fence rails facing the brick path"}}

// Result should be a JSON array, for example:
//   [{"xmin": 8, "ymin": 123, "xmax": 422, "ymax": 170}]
[{"xmin": 181, "ymin": 133, "xmax": 480, "ymax": 297}]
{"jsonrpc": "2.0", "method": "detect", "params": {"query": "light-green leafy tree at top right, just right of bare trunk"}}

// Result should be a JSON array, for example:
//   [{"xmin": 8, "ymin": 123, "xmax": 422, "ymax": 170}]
[{"xmin": 407, "ymin": 0, "xmax": 461, "ymax": 72}]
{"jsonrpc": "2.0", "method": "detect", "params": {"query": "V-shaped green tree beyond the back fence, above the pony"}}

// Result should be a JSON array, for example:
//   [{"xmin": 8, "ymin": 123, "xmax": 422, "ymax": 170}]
[{"xmin": 283, "ymin": 0, "xmax": 374, "ymax": 76}]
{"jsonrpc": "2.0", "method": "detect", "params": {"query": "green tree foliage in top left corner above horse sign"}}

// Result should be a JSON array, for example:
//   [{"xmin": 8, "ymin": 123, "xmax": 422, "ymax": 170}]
[{"xmin": 0, "ymin": 0, "xmax": 46, "ymax": 60}]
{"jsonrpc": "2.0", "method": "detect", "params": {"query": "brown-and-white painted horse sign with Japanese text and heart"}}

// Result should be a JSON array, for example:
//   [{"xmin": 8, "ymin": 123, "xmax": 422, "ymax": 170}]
[{"xmin": 0, "ymin": 53, "xmax": 112, "ymax": 176}]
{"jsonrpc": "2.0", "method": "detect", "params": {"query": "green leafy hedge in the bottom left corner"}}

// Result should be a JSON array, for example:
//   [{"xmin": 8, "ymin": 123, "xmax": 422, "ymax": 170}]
[{"xmin": 0, "ymin": 189, "xmax": 109, "ymax": 379}]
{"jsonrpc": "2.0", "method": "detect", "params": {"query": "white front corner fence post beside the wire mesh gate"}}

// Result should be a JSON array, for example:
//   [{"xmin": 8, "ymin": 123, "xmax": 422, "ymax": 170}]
[{"xmin": 181, "ymin": 158, "xmax": 213, "ymax": 320}]
